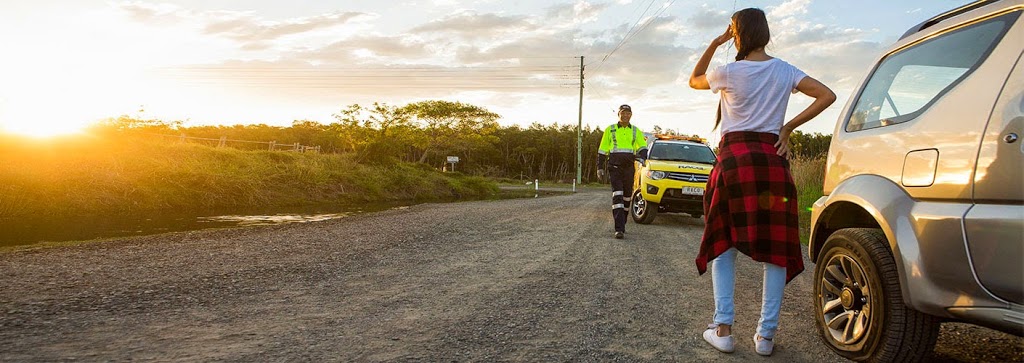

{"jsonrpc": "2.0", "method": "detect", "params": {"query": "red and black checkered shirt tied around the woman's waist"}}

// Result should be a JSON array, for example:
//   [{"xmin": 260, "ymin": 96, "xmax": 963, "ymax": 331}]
[{"xmin": 696, "ymin": 131, "xmax": 804, "ymax": 283}]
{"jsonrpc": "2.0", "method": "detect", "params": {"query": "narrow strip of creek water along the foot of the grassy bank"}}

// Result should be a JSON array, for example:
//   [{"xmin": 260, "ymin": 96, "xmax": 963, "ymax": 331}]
[{"xmin": 0, "ymin": 202, "xmax": 407, "ymax": 247}]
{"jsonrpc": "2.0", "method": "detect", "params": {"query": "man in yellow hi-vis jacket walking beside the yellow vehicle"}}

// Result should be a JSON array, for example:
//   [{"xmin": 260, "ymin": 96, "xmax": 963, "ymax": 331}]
[{"xmin": 597, "ymin": 105, "xmax": 647, "ymax": 238}]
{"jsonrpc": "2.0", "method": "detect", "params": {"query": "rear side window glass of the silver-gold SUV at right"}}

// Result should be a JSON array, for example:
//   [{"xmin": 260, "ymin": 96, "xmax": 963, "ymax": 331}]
[{"xmin": 846, "ymin": 11, "xmax": 1020, "ymax": 131}]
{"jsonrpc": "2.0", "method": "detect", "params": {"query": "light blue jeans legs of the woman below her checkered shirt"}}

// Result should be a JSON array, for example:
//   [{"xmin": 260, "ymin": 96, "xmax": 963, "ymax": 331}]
[{"xmin": 711, "ymin": 248, "xmax": 785, "ymax": 339}]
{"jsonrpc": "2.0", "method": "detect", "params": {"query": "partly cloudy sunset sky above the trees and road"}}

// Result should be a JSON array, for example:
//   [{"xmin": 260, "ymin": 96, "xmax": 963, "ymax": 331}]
[{"xmin": 0, "ymin": 0, "xmax": 970, "ymax": 138}]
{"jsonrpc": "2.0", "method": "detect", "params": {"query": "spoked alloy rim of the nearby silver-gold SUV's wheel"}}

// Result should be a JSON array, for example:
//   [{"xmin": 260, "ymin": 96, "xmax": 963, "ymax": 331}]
[{"xmin": 818, "ymin": 254, "xmax": 871, "ymax": 345}]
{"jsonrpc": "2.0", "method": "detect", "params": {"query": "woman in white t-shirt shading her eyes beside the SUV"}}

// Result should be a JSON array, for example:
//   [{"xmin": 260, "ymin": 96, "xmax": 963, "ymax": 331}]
[{"xmin": 689, "ymin": 8, "xmax": 836, "ymax": 356}]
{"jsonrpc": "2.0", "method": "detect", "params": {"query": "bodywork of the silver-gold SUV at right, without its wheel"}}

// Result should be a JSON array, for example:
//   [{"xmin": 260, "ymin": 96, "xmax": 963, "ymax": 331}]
[{"xmin": 809, "ymin": 0, "xmax": 1024, "ymax": 335}]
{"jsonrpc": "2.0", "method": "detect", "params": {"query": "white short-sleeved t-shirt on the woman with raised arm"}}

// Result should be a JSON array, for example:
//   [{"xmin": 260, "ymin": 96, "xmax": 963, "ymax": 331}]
[{"xmin": 708, "ymin": 58, "xmax": 807, "ymax": 134}]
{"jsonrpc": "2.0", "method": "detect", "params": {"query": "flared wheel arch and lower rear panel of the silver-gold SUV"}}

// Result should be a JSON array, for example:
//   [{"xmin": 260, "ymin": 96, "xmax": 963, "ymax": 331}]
[{"xmin": 809, "ymin": 175, "xmax": 1006, "ymax": 317}]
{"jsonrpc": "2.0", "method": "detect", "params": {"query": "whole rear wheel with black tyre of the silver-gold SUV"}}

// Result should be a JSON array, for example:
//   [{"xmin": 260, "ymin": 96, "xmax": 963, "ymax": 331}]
[{"xmin": 814, "ymin": 228, "xmax": 940, "ymax": 362}]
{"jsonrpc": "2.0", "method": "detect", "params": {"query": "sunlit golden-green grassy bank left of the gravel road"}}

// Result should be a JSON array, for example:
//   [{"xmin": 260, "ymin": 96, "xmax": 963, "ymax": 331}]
[{"xmin": 0, "ymin": 133, "xmax": 498, "ymax": 217}]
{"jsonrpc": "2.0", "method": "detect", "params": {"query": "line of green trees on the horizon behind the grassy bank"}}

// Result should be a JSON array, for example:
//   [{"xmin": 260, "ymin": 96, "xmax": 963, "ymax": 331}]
[{"xmin": 96, "ymin": 100, "xmax": 831, "ymax": 183}]
